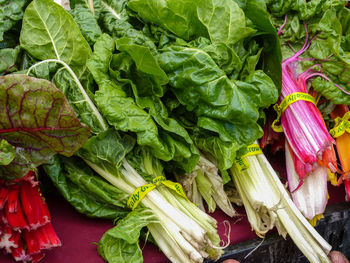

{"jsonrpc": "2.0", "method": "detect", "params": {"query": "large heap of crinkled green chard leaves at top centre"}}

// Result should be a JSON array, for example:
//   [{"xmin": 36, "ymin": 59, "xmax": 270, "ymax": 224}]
[{"xmin": 85, "ymin": 1, "xmax": 281, "ymax": 215}]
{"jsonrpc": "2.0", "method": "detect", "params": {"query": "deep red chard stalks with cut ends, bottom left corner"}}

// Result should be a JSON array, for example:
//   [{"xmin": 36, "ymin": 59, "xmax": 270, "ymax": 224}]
[{"xmin": 0, "ymin": 171, "xmax": 61, "ymax": 262}]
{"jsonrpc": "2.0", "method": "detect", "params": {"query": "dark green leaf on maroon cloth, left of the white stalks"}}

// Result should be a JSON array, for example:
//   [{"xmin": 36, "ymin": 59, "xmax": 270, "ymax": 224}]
[{"xmin": 44, "ymin": 155, "xmax": 130, "ymax": 220}]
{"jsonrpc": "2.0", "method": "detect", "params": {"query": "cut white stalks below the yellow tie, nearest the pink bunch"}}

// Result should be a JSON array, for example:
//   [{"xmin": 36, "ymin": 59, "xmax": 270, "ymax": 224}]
[{"xmin": 231, "ymin": 151, "xmax": 332, "ymax": 263}]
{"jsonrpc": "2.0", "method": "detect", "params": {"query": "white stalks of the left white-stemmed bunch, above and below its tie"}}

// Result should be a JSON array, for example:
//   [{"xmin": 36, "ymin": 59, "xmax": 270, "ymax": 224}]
[{"xmin": 85, "ymin": 159, "xmax": 223, "ymax": 263}]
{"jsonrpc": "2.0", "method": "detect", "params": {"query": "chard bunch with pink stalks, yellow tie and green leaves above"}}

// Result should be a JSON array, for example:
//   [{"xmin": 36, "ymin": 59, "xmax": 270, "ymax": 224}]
[{"xmin": 267, "ymin": 0, "xmax": 350, "ymax": 219}]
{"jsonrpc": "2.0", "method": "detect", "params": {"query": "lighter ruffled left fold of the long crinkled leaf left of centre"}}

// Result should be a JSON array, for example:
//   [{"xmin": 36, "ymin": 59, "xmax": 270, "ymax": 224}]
[{"xmin": 88, "ymin": 34, "xmax": 171, "ymax": 161}]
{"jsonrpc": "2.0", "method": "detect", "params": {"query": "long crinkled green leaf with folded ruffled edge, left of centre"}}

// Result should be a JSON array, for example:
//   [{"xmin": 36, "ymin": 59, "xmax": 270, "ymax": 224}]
[{"xmin": 88, "ymin": 35, "xmax": 199, "ymax": 171}]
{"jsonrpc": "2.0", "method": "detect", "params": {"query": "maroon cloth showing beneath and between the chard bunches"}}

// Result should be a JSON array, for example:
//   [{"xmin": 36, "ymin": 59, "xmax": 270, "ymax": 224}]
[{"xmin": 0, "ymin": 154, "xmax": 345, "ymax": 263}]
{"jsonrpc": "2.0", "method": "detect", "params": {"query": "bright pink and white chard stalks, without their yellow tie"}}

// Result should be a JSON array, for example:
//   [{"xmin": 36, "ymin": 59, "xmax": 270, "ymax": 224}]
[{"xmin": 279, "ymin": 26, "xmax": 337, "ymax": 219}]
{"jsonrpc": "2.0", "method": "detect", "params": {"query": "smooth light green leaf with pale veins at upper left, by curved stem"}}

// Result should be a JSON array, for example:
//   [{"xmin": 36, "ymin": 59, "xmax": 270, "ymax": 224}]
[{"xmin": 20, "ymin": 0, "xmax": 107, "ymax": 134}]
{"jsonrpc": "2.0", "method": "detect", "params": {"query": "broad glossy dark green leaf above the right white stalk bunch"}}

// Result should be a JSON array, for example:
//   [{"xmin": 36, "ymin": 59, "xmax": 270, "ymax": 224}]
[{"xmin": 158, "ymin": 46, "xmax": 278, "ymax": 169}]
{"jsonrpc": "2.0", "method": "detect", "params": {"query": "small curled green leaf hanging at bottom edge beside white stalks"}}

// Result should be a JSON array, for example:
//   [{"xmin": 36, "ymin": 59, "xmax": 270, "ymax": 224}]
[{"xmin": 98, "ymin": 208, "xmax": 157, "ymax": 263}]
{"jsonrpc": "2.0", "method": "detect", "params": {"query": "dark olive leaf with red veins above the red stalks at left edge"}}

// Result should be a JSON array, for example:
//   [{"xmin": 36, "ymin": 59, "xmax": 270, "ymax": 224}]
[{"xmin": 0, "ymin": 74, "xmax": 90, "ymax": 178}]
